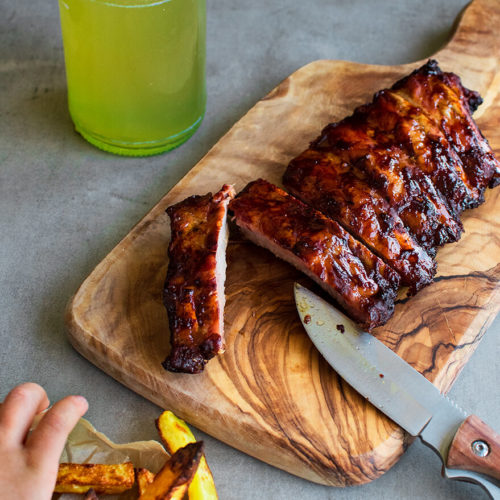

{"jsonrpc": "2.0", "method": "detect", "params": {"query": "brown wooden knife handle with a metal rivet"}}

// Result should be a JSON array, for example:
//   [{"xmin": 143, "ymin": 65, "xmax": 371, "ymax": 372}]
[{"xmin": 446, "ymin": 415, "xmax": 500, "ymax": 480}]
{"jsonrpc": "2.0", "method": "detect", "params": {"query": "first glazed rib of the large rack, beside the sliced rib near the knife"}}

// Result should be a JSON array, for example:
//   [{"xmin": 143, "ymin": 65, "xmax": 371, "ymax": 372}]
[{"xmin": 283, "ymin": 146, "xmax": 435, "ymax": 293}]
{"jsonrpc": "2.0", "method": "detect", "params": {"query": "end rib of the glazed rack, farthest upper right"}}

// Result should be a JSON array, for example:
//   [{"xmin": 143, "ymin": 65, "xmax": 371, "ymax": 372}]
[{"xmin": 392, "ymin": 60, "xmax": 500, "ymax": 196}]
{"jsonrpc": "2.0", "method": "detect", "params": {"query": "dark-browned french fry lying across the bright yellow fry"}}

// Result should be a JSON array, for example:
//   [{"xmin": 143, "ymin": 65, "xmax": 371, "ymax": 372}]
[{"xmin": 139, "ymin": 441, "xmax": 203, "ymax": 500}]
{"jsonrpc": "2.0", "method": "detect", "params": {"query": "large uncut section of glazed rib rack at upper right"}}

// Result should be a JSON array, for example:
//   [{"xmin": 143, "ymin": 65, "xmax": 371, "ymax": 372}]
[{"xmin": 283, "ymin": 61, "xmax": 500, "ymax": 293}]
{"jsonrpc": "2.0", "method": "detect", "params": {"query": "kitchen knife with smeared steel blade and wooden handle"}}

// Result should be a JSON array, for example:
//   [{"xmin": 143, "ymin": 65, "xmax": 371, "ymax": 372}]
[{"xmin": 295, "ymin": 283, "xmax": 500, "ymax": 500}]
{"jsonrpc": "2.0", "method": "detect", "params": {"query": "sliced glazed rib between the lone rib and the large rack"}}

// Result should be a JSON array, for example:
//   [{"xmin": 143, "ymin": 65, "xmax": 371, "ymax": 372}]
[{"xmin": 229, "ymin": 179, "xmax": 400, "ymax": 330}]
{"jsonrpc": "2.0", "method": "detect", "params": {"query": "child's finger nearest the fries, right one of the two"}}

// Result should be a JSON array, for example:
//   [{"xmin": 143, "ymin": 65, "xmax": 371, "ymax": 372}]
[{"xmin": 26, "ymin": 396, "xmax": 88, "ymax": 470}]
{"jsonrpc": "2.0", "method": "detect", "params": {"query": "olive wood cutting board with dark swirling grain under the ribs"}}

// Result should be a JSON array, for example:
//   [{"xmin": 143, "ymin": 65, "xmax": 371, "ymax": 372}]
[{"xmin": 67, "ymin": 0, "xmax": 500, "ymax": 486}]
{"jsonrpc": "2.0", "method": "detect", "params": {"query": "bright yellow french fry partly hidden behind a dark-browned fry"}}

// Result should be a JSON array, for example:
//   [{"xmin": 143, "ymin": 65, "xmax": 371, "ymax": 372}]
[{"xmin": 156, "ymin": 411, "xmax": 219, "ymax": 500}]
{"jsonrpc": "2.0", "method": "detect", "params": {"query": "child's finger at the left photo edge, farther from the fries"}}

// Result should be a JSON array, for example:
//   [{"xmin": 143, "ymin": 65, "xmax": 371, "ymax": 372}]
[{"xmin": 0, "ymin": 382, "xmax": 49, "ymax": 445}]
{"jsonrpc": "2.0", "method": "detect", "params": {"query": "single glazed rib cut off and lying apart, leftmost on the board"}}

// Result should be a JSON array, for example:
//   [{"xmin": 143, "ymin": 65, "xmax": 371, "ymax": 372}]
[{"xmin": 163, "ymin": 185, "xmax": 235, "ymax": 373}]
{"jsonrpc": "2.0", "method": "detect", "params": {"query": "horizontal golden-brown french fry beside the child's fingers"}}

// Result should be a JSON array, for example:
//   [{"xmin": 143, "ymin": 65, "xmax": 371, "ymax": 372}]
[{"xmin": 54, "ymin": 462, "xmax": 135, "ymax": 495}]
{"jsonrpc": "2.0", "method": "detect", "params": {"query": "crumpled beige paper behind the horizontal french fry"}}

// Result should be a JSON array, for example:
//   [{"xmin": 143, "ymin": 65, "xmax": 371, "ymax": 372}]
[{"xmin": 48, "ymin": 418, "xmax": 169, "ymax": 500}]
